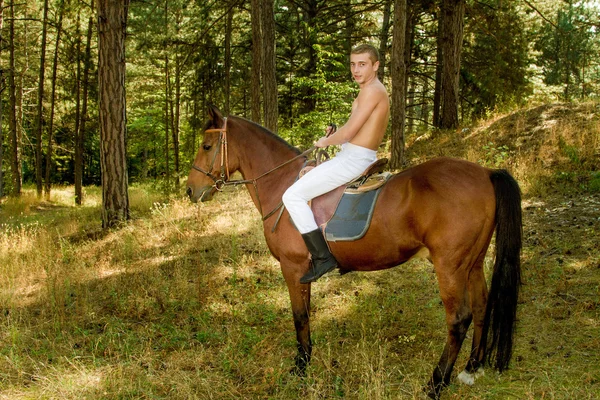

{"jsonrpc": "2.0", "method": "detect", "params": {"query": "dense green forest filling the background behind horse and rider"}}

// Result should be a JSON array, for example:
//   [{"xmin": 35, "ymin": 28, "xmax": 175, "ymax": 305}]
[{"xmin": 0, "ymin": 0, "xmax": 600, "ymax": 196}]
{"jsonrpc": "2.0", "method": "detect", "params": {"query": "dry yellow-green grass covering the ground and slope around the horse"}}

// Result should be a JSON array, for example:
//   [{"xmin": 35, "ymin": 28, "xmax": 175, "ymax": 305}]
[{"xmin": 0, "ymin": 104, "xmax": 600, "ymax": 399}]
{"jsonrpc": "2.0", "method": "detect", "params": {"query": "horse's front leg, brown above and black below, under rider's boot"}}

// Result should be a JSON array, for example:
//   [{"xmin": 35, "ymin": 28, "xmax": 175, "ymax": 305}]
[{"xmin": 281, "ymin": 260, "xmax": 312, "ymax": 376}]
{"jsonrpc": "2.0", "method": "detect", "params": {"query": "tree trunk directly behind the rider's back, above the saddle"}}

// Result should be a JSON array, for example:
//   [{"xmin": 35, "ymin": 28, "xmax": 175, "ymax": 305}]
[{"xmin": 390, "ymin": 0, "xmax": 407, "ymax": 169}]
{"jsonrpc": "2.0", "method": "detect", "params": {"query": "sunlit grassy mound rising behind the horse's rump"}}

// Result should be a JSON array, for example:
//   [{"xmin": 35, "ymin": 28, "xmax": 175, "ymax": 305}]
[{"xmin": 407, "ymin": 102, "xmax": 600, "ymax": 196}]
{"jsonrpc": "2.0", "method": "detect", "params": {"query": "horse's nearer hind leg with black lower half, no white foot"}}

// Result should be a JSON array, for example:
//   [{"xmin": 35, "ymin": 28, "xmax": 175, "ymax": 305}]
[{"xmin": 426, "ymin": 262, "xmax": 472, "ymax": 399}]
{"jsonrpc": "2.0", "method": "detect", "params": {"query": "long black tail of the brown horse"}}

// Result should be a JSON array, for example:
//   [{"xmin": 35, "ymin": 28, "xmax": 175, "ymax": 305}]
[{"xmin": 481, "ymin": 170, "xmax": 523, "ymax": 372}]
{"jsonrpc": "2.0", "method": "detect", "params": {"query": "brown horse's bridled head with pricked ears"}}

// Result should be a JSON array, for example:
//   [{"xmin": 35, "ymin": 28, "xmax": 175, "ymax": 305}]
[{"xmin": 186, "ymin": 106, "xmax": 230, "ymax": 203}]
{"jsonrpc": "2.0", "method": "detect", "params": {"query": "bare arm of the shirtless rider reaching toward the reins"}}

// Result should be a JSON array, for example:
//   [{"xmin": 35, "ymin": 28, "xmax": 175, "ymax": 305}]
[{"xmin": 315, "ymin": 88, "xmax": 382, "ymax": 147}]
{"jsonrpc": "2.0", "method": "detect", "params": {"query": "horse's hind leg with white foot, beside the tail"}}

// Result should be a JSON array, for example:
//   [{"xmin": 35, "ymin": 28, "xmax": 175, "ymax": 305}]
[{"xmin": 458, "ymin": 260, "xmax": 487, "ymax": 385}]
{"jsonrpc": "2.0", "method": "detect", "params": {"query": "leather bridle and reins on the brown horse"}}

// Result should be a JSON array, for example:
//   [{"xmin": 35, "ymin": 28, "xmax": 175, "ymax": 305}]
[{"xmin": 192, "ymin": 117, "xmax": 317, "ymax": 230}]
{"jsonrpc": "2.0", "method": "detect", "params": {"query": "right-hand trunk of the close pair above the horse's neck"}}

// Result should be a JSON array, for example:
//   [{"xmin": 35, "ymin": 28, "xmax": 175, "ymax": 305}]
[{"xmin": 261, "ymin": 0, "xmax": 279, "ymax": 132}]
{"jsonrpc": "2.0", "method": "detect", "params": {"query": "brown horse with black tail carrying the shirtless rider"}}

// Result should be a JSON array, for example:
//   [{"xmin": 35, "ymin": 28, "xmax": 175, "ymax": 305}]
[{"xmin": 187, "ymin": 107, "xmax": 522, "ymax": 398}]
